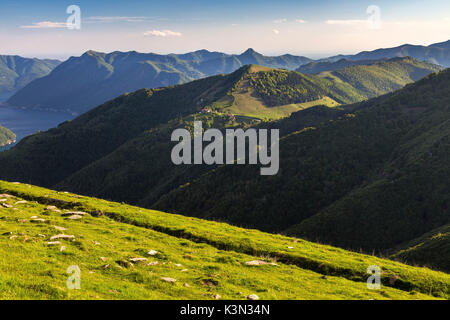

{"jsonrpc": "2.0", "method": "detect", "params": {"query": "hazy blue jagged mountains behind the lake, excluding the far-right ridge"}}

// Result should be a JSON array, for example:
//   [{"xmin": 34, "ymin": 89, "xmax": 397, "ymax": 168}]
[{"xmin": 8, "ymin": 49, "xmax": 311, "ymax": 114}]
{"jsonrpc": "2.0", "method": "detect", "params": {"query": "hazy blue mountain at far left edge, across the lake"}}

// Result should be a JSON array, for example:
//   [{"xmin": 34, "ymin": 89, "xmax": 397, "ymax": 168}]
[{"xmin": 0, "ymin": 55, "xmax": 61, "ymax": 101}]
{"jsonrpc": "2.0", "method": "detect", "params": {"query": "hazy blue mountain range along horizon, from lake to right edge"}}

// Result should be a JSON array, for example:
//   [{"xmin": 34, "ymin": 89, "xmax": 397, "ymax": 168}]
[{"xmin": 8, "ymin": 38, "xmax": 450, "ymax": 114}]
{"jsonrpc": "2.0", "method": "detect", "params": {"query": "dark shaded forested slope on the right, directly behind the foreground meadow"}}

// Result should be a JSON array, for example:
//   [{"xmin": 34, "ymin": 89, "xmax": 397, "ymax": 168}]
[{"xmin": 155, "ymin": 70, "xmax": 450, "ymax": 268}]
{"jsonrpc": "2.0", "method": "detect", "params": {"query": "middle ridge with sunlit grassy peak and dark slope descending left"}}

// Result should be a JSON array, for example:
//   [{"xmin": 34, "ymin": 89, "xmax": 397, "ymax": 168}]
[{"xmin": 0, "ymin": 60, "xmax": 431, "ymax": 201}]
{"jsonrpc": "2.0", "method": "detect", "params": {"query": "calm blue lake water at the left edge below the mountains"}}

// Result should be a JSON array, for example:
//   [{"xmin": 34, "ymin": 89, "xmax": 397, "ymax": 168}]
[{"xmin": 0, "ymin": 105, "xmax": 74, "ymax": 151}]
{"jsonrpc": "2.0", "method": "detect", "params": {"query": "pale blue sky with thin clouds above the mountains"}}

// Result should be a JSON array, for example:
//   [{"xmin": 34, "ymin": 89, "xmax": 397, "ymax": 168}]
[{"xmin": 0, "ymin": 0, "xmax": 450, "ymax": 58}]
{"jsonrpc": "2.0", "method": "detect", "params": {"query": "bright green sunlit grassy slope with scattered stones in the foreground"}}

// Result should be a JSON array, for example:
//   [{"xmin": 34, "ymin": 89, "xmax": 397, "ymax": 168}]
[{"xmin": 0, "ymin": 181, "xmax": 450, "ymax": 300}]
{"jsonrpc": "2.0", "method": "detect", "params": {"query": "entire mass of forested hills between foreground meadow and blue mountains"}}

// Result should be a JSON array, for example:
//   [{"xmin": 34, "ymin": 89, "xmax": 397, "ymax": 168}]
[{"xmin": 0, "ymin": 57, "xmax": 444, "ymax": 268}]
